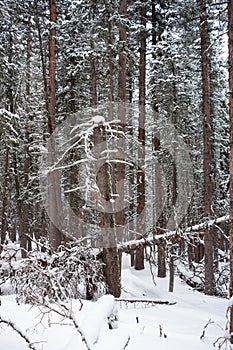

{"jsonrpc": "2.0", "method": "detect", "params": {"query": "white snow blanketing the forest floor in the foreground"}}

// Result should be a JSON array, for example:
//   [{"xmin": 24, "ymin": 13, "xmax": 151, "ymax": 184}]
[{"xmin": 0, "ymin": 256, "xmax": 230, "ymax": 350}]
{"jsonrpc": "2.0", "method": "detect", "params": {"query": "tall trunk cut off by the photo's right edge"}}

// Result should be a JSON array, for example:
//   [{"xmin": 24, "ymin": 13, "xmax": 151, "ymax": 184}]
[{"xmin": 228, "ymin": 0, "xmax": 233, "ymax": 344}]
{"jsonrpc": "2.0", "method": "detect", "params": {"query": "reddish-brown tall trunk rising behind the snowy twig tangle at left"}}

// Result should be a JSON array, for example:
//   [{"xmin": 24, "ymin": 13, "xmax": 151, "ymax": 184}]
[{"xmin": 48, "ymin": 0, "xmax": 63, "ymax": 250}]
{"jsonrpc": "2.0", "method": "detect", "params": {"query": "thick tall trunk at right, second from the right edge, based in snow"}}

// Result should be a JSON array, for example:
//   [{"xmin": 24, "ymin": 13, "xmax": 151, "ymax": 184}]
[{"xmin": 199, "ymin": 0, "xmax": 215, "ymax": 295}]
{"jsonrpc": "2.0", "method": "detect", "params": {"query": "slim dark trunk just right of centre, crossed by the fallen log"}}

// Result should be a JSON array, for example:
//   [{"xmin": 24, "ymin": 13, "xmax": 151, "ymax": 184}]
[{"xmin": 135, "ymin": 0, "xmax": 147, "ymax": 270}]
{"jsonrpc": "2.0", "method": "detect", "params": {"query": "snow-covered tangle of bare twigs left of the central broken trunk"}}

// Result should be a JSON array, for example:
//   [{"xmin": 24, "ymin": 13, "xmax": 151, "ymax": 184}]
[{"xmin": 2, "ymin": 243, "xmax": 105, "ymax": 304}]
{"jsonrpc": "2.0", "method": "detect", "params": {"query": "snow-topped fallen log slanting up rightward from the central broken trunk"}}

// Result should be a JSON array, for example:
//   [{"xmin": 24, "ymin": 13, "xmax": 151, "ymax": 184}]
[{"xmin": 118, "ymin": 215, "xmax": 229, "ymax": 252}]
